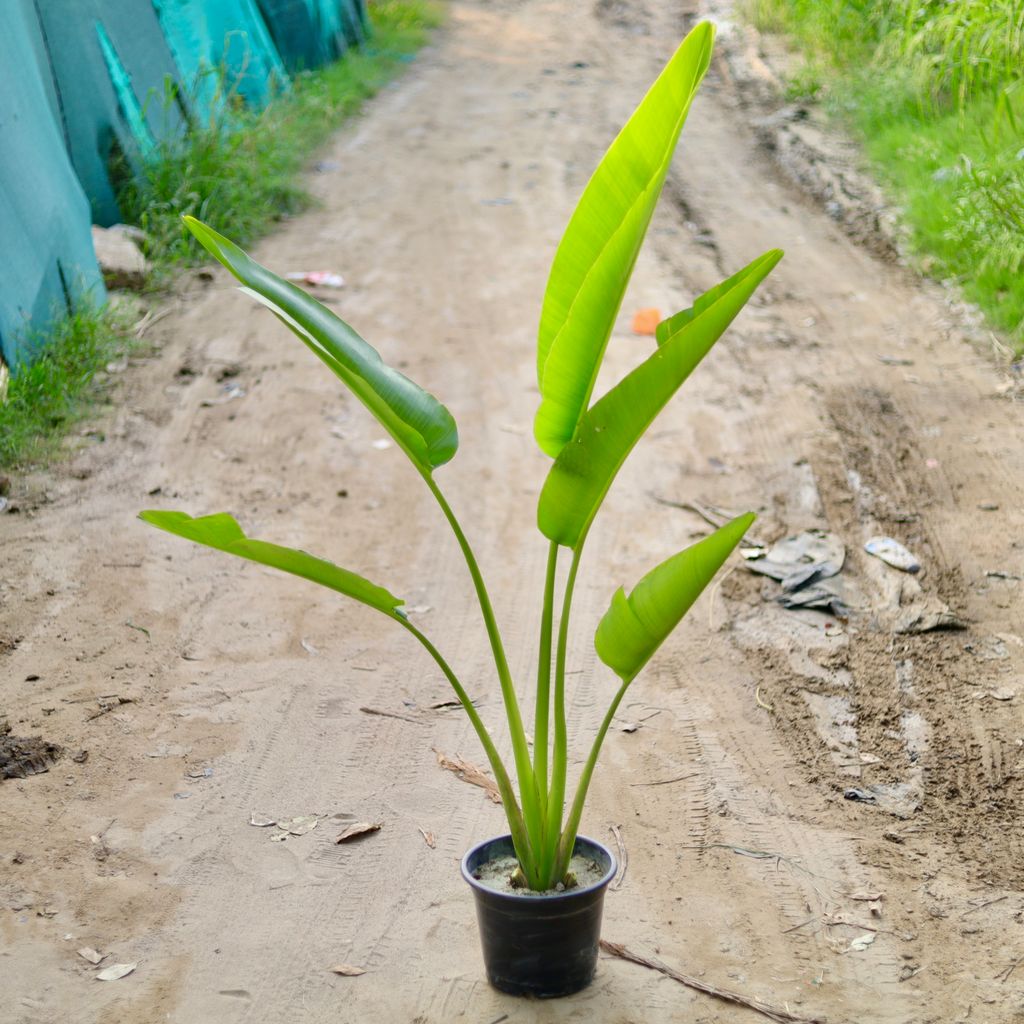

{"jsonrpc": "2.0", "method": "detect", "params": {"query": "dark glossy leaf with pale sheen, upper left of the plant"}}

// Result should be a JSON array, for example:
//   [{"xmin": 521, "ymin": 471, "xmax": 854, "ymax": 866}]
[{"xmin": 184, "ymin": 217, "xmax": 459, "ymax": 472}]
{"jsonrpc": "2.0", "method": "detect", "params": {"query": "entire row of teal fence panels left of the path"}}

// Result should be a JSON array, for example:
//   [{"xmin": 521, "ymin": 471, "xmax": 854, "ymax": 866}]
[{"xmin": 0, "ymin": 0, "xmax": 368, "ymax": 370}]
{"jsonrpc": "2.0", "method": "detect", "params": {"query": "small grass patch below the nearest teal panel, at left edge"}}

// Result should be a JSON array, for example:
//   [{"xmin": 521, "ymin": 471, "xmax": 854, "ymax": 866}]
[{"xmin": 0, "ymin": 304, "xmax": 137, "ymax": 469}]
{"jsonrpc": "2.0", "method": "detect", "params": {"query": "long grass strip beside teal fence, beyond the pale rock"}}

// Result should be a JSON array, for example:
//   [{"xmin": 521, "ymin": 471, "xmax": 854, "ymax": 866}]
[{"xmin": 119, "ymin": 0, "xmax": 440, "ymax": 272}]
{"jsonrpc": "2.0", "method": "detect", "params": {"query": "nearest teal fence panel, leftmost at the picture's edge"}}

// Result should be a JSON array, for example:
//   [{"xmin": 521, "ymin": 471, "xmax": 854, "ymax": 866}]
[{"xmin": 0, "ymin": 0, "xmax": 105, "ymax": 371}]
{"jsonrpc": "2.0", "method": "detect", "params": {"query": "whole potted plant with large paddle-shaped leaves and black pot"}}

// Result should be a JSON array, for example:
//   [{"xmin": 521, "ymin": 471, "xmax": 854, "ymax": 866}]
[{"xmin": 141, "ymin": 24, "xmax": 782, "ymax": 995}]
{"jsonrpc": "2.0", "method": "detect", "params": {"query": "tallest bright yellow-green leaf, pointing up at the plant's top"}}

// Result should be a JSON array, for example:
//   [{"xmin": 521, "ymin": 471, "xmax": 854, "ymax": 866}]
[{"xmin": 534, "ymin": 23, "xmax": 715, "ymax": 458}]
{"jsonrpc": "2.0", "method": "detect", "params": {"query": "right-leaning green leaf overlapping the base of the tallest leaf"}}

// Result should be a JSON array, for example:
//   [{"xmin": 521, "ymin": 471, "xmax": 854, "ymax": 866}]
[{"xmin": 538, "ymin": 249, "xmax": 782, "ymax": 548}]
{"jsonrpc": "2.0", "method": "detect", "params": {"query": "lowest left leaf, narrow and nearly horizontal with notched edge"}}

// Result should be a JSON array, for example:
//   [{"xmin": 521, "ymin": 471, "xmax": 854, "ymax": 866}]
[{"xmin": 138, "ymin": 511, "xmax": 406, "ymax": 618}]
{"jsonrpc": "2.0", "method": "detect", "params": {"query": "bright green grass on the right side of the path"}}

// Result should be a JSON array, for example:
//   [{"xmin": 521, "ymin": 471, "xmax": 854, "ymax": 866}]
[{"xmin": 746, "ymin": 0, "xmax": 1024, "ymax": 352}]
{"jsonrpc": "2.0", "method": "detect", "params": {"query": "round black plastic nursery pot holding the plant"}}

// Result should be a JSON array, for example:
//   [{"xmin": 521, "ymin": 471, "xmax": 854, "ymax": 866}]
[{"xmin": 462, "ymin": 836, "xmax": 615, "ymax": 998}]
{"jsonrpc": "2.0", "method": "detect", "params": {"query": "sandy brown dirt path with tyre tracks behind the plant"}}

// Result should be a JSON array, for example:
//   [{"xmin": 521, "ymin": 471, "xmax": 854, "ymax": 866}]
[{"xmin": 0, "ymin": 0, "xmax": 1024, "ymax": 1024}]
